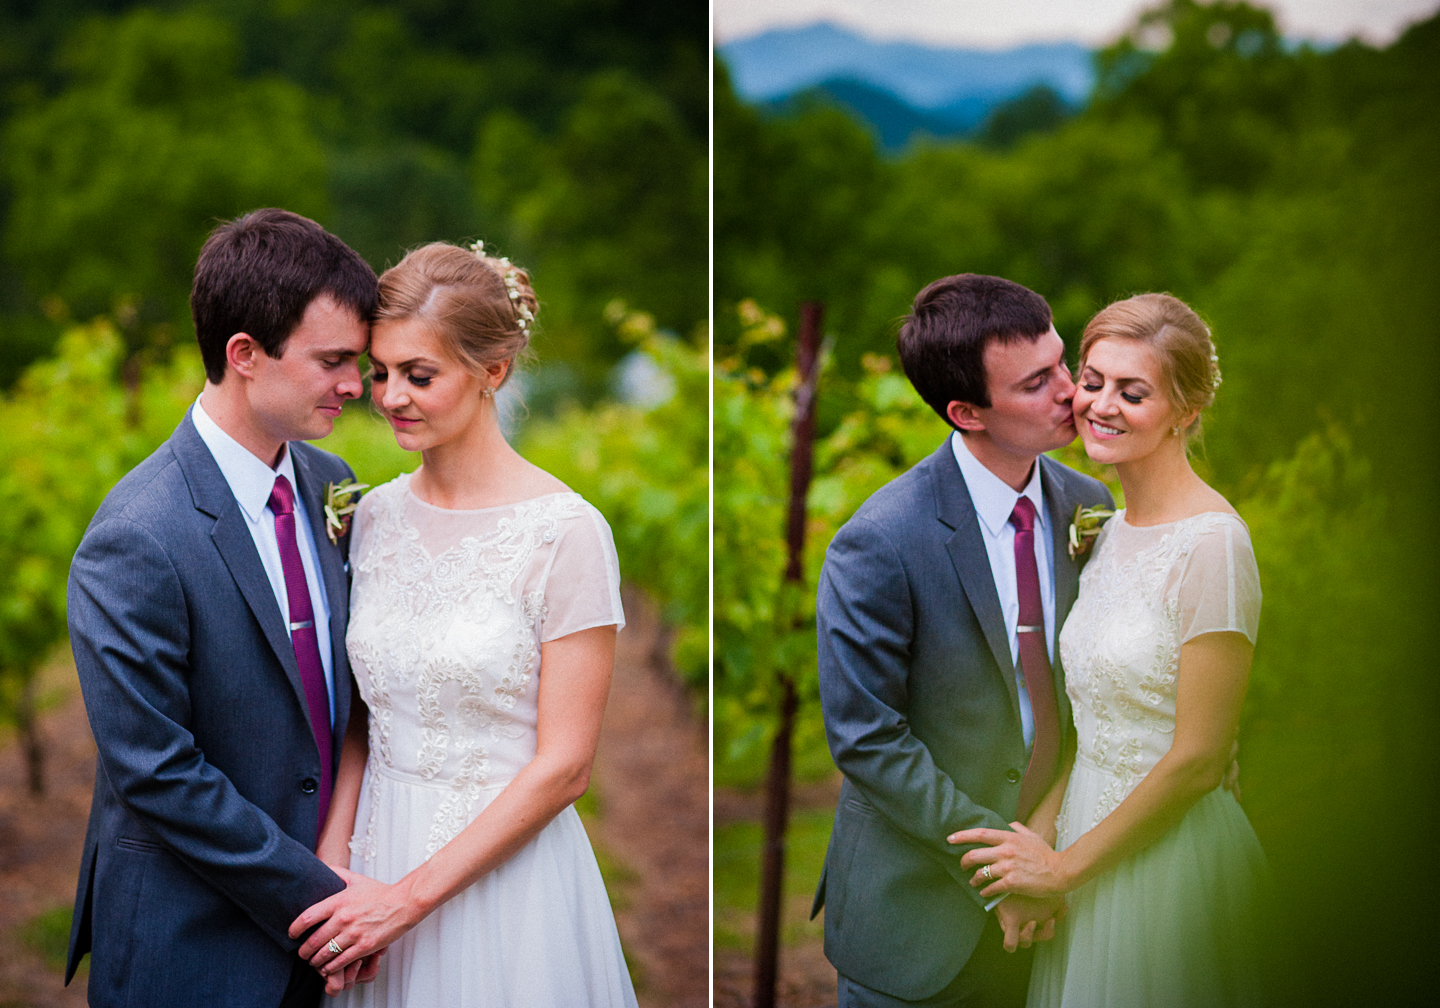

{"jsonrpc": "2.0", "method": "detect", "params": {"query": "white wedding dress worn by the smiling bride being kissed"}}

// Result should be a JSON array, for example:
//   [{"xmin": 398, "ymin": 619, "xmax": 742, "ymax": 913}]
[{"xmin": 1028, "ymin": 511, "xmax": 1267, "ymax": 1008}]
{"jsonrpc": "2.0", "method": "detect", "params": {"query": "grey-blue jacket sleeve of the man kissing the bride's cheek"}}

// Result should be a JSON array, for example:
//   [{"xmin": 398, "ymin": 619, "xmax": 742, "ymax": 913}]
[{"xmin": 816, "ymin": 520, "xmax": 1009, "ymax": 907}]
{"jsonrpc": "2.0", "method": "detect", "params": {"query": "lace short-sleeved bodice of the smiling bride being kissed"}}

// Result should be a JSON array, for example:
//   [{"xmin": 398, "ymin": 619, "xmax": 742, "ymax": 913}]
[{"xmin": 1057, "ymin": 511, "xmax": 1260, "ymax": 837}]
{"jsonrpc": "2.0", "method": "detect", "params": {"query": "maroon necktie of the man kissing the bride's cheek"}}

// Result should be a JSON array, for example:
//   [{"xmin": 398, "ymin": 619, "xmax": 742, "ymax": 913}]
[{"xmin": 1009, "ymin": 497, "xmax": 1060, "ymax": 822}]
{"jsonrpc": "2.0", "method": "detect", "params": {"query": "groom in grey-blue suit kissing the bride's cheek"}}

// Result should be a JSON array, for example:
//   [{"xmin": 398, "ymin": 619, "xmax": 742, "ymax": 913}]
[{"xmin": 815, "ymin": 274, "xmax": 1112, "ymax": 1008}]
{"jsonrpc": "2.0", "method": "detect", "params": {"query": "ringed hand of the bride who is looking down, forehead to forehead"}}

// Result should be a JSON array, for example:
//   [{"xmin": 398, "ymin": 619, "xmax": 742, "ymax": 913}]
[{"xmin": 289, "ymin": 867, "xmax": 425, "ymax": 991}]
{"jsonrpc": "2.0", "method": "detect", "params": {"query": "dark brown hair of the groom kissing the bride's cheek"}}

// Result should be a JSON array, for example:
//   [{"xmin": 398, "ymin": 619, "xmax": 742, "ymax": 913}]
[{"xmin": 896, "ymin": 274, "xmax": 1051, "ymax": 426}]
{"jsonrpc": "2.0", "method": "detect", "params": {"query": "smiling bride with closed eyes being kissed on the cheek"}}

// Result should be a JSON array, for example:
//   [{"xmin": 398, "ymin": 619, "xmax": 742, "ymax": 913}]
[{"xmin": 950, "ymin": 294, "xmax": 1266, "ymax": 1008}]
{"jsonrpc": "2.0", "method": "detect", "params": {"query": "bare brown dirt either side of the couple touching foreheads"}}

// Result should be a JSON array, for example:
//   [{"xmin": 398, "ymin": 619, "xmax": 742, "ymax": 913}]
[{"xmin": 0, "ymin": 593, "xmax": 708, "ymax": 1008}]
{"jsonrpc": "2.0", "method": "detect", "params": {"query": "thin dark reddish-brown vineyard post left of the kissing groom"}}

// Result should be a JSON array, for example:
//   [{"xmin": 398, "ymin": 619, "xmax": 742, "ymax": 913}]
[{"xmin": 755, "ymin": 301, "xmax": 825, "ymax": 1008}]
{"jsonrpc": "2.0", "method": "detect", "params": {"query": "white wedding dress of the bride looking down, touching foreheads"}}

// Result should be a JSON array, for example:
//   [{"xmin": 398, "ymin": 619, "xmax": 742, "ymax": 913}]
[{"xmin": 338, "ymin": 475, "xmax": 635, "ymax": 1008}]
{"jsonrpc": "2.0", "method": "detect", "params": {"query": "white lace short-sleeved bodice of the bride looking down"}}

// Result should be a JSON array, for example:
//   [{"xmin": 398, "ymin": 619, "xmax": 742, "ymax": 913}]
[{"xmin": 346, "ymin": 474, "xmax": 625, "ymax": 857}]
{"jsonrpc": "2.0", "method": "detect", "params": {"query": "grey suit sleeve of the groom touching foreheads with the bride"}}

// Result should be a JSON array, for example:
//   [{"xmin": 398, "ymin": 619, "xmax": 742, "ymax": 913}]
[{"xmin": 68, "ymin": 520, "xmax": 344, "ymax": 950}]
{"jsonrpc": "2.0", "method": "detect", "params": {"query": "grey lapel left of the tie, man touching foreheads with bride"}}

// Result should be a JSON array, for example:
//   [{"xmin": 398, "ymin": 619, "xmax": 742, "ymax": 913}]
[{"xmin": 170, "ymin": 413, "xmax": 308, "ymax": 710}]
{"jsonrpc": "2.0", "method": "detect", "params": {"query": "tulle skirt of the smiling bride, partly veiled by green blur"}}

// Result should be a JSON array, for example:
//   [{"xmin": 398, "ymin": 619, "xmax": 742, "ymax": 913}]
[{"xmin": 1028, "ymin": 760, "xmax": 1269, "ymax": 1008}]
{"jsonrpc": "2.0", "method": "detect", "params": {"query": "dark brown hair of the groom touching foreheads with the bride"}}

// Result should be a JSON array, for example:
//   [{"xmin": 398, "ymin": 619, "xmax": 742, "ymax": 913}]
[{"xmin": 190, "ymin": 207, "xmax": 379, "ymax": 384}]
